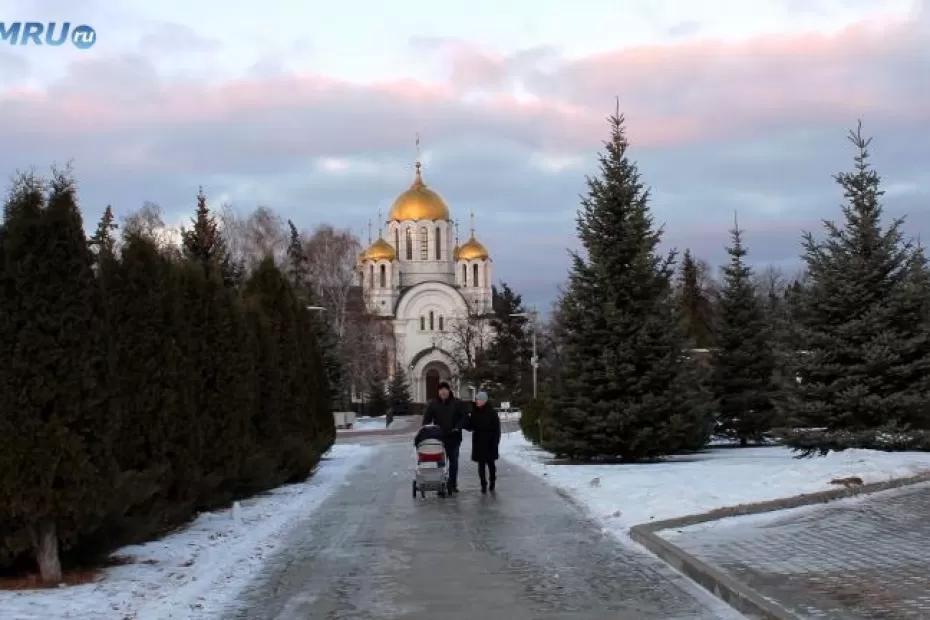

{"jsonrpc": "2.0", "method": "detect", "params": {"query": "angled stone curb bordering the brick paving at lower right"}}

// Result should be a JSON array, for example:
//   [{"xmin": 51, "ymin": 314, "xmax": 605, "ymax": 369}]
[{"xmin": 630, "ymin": 471, "xmax": 930, "ymax": 620}]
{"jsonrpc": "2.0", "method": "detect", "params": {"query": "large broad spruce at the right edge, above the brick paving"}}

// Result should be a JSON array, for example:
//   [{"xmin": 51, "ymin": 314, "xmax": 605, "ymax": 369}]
[{"xmin": 783, "ymin": 124, "xmax": 930, "ymax": 453}]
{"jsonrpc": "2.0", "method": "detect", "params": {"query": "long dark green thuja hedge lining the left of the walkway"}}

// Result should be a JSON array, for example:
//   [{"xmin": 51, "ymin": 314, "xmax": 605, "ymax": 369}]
[{"xmin": 0, "ymin": 172, "xmax": 335, "ymax": 581}]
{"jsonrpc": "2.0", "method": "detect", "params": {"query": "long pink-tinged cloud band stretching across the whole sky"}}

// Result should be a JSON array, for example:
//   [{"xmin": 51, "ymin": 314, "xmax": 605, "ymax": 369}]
[{"xmin": 0, "ymin": 10, "xmax": 930, "ymax": 173}]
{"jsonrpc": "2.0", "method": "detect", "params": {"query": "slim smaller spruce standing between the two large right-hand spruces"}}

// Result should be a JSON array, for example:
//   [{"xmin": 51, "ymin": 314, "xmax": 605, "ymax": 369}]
[{"xmin": 712, "ymin": 220, "xmax": 776, "ymax": 445}]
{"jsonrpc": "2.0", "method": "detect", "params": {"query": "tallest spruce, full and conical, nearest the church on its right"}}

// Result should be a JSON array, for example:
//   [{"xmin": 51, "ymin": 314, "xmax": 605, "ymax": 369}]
[{"xmin": 544, "ymin": 113, "xmax": 713, "ymax": 460}]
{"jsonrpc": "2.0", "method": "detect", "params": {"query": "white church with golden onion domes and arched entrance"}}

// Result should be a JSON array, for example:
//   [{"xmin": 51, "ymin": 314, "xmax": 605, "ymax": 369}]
[{"xmin": 358, "ymin": 161, "xmax": 493, "ymax": 402}]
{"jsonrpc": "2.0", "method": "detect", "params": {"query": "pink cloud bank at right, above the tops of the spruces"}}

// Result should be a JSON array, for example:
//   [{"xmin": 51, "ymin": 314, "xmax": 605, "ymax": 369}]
[{"xmin": 527, "ymin": 16, "xmax": 930, "ymax": 145}]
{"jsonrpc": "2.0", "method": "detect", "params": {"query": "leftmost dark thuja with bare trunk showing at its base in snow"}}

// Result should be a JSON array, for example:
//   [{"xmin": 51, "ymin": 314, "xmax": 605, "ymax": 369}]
[{"xmin": 0, "ymin": 170, "xmax": 114, "ymax": 583}]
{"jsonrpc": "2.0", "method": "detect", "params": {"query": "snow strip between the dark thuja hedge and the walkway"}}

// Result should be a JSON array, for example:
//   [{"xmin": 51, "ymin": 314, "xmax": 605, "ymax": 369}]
[{"xmin": 0, "ymin": 444, "xmax": 377, "ymax": 620}]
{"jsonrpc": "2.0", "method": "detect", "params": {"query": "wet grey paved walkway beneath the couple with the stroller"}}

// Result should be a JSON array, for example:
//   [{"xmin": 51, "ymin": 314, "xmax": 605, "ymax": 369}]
[{"xmin": 223, "ymin": 437, "xmax": 740, "ymax": 620}]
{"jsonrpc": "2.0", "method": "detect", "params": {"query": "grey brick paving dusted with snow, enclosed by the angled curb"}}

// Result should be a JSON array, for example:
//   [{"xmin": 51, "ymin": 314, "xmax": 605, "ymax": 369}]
[{"xmin": 661, "ymin": 484, "xmax": 930, "ymax": 620}]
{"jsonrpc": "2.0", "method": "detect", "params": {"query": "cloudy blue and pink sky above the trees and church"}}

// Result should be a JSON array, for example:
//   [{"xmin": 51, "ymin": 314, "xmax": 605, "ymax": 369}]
[{"xmin": 0, "ymin": 0, "xmax": 930, "ymax": 307}]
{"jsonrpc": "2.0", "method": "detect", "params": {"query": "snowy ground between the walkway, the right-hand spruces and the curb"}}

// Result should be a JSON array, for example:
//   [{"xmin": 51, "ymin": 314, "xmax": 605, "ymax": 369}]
[{"xmin": 501, "ymin": 432, "xmax": 930, "ymax": 540}]
